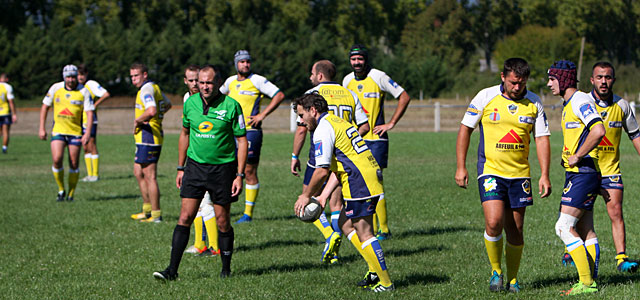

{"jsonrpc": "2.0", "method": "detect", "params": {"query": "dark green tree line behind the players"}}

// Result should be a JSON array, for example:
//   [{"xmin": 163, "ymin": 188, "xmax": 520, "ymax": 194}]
[{"xmin": 0, "ymin": 0, "xmax": 640, "ymax": 99}]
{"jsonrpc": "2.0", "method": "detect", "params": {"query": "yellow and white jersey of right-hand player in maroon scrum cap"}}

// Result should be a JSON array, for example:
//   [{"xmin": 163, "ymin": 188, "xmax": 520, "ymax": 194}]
[{"xmin": 562, "ymin": 91, "xmax": 602, "ymax": 173}]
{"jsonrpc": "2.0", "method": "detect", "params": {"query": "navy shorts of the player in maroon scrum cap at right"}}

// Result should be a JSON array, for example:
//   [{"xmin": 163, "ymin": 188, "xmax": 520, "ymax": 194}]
[{"xmin": 560, "ymin": 172, "xmax": 602, "ymax": 211}]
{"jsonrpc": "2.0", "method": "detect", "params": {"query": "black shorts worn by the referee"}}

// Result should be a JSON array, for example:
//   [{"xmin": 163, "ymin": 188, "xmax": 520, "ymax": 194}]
[{"xmin": 180, "ymin": 158, "xmax": 238, "ymax": 205}]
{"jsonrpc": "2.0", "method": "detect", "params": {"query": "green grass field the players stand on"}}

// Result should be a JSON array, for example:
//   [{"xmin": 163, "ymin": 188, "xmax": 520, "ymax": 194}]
[{"xmin": 0, "ymin": 132, "xmax": 640, "ymax": 299}]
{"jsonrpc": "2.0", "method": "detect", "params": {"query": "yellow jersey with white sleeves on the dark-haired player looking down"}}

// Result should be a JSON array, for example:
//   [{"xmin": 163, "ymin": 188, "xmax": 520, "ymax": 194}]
[{"xmin": 461, "ymin": 85, "xmax": 550, "ymax": 179}]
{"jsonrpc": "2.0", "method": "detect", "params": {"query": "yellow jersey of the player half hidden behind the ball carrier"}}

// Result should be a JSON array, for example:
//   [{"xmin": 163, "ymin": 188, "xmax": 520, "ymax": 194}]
[{"xmin": 298, "ymin": 82, "xmax": 368, "ymax": 168}]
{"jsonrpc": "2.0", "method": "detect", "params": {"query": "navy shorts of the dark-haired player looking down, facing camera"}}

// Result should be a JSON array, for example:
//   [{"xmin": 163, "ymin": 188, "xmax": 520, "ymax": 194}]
[{"xmin": 478, "ymin": 175, "xmax": 533, "ymax": 208}]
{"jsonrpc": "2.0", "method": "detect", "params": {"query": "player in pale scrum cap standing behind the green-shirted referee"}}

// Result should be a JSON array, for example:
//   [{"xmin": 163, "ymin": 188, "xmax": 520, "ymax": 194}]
[{"xmin": 220, "ymin": 50, "xmax": 284, "ymax": 223}]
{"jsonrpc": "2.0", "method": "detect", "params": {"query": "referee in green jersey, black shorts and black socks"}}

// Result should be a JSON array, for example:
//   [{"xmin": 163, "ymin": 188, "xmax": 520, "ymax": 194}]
[{"xmin": 153, "ymin": 65, "xmax": 248, "ymax": 280}]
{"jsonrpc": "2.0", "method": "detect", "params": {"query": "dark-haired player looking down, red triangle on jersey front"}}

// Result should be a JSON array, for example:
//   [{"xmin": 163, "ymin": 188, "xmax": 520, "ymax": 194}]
[{"xmin": 455, "ymin": 58, "xmax": 551, "ymax": 292}]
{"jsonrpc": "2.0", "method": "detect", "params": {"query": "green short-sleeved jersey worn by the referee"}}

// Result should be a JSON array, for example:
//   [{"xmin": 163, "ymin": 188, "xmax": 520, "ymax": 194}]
[{"xmin": 182, "ymin": 93, "xmax": 247, "ymax": 165}]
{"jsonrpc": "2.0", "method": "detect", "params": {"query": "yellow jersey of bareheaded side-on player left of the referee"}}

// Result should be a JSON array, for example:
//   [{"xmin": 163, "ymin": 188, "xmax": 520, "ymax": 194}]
[{"xmin": 134, "ymin": 81, "xmax": 171, "ymax": 145}]
